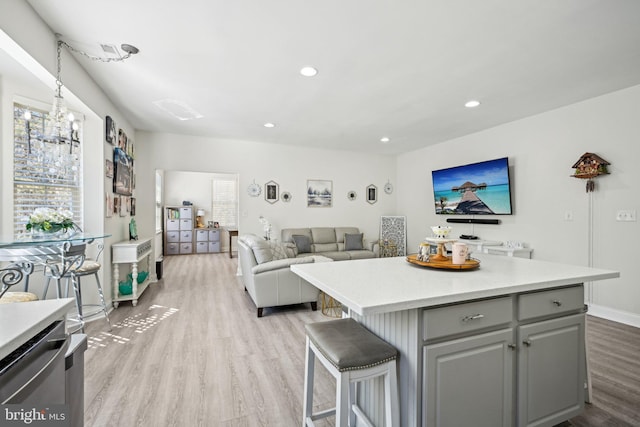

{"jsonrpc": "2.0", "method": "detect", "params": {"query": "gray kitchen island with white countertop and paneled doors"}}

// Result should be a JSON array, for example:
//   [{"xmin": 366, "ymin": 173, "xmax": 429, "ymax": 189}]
[{"xmin": 291, "ymin": 254, "xmax": 619, "ymax": 427}]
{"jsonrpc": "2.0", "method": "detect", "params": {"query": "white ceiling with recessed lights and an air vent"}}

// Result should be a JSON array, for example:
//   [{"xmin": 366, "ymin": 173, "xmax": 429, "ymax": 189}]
[{"xmin": 22, "ymin": 0, "xmax": 640, "ymax": 154}]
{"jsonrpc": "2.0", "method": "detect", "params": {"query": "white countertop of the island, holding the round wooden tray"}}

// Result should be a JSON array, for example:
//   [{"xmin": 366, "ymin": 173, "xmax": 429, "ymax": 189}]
[{"xmin": 291, "ymin": 253, "xmax": 620, "ymax": 316}]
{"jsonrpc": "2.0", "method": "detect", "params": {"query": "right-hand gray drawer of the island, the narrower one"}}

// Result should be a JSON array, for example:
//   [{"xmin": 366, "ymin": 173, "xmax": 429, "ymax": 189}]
[{"xmin": 518, "ymin": 285, "xmax": 584, "ymax": 320}]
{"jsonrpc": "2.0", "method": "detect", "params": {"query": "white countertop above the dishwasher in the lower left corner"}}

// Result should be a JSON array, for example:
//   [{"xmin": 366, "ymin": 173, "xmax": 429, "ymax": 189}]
[{"xmin": 0, "ymin": 298, "xmax": 75, "ymax": 360}]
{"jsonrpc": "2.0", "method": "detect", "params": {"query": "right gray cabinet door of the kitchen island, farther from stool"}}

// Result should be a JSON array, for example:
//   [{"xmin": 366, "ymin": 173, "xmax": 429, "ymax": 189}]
[{"xmin": 517, "ymin": 314, "xmax": 585, "ymax": 427}]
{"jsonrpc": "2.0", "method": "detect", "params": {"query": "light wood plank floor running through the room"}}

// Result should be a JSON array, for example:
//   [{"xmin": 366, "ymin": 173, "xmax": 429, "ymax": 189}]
[{"xmin": 85, "ymin": 254, "xmax": 640, "ymax": 427}]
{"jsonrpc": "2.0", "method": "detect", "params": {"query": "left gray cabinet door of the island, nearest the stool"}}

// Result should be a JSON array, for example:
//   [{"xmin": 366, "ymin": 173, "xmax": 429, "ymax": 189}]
[{"xmin": 422, "ymin": 328, "xmax": 515, "ymax": 427}]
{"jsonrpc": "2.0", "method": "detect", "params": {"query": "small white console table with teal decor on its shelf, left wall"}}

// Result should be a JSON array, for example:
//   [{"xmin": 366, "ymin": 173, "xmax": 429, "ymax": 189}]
[{"xmin": 111, "ymin": 238, "xmax": 152, "ymax": 308}]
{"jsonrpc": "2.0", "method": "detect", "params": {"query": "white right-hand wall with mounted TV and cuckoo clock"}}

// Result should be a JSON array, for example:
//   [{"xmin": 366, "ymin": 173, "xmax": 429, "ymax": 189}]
[{"xmin": 396, "ymin": 86, "xmax": 640, "ymax": 326}]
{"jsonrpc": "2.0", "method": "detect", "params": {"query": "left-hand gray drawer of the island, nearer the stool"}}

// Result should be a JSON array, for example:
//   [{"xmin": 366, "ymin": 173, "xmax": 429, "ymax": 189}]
[{"xmin": 423, "ymin": 297, "xmax": 513, "ymax": 340}]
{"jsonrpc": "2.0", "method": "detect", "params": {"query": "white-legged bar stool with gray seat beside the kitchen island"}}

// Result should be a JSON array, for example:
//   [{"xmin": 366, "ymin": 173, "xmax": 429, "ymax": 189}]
[{"xmin": 302, "ymin": 318, "xmax": 400, "ymax": 427}]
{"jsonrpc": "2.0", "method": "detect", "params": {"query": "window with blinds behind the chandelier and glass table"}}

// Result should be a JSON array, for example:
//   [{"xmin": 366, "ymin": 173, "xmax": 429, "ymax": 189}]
[{"xmin": 13, "ymin": 103, "xmax": 83, "ymax": 237}]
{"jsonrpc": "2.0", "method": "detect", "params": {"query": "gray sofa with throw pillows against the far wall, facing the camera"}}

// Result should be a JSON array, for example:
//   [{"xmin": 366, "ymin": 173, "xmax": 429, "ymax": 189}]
[{"xmin": 281, "ymin": 227, "xmax": 379, "ymax": 261}]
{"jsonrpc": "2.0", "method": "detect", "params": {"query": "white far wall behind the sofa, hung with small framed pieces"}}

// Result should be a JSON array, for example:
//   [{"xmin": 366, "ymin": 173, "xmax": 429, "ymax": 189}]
[{"xmin": 136, "ymin": 132, "xmax": 396, "ymax": 254}]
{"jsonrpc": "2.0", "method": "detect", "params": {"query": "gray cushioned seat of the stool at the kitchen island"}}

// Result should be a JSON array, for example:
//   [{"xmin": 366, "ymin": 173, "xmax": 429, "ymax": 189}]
[{"xmin": 306, "ymin": 318, "xmax": 398, "ymax": 372}]
